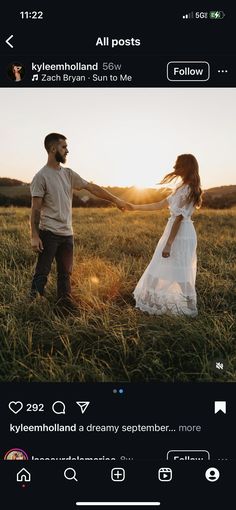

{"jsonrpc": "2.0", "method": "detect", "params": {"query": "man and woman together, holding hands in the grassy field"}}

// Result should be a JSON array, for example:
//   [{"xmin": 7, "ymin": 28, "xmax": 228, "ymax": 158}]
[{"xmin": 30, "ymin": 133, "xmax": 202, "ymax": 317}]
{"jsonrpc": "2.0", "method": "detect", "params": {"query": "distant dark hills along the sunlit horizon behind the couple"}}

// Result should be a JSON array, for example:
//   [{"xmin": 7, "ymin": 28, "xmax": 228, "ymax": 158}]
[{"xmin": 0, "ymin": 177, "xmax": 236, "ymax": 209}]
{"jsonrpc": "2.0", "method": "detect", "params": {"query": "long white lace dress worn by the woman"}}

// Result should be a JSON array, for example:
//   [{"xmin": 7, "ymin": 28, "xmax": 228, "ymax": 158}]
[{"xmin": 133, "ymin": 184, "xmax": 197, "ymax": 317}]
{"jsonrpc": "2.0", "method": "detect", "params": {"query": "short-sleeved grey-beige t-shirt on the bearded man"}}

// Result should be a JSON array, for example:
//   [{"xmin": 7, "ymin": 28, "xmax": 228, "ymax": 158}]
[{"xmin": 30, "ymin": 165, "xmax": 88, "ymax": 236}]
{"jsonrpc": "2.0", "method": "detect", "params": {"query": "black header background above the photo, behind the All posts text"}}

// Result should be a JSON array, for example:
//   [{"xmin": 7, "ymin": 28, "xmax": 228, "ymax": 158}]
[{"xmin": 0, "ymin": 0, "xmax": 236, "ymax": 87}]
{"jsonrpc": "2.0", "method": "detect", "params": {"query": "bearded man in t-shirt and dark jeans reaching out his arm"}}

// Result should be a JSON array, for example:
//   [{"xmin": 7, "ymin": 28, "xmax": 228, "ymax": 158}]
[{"xmin": 30, "ymin": 133, "xmax": 129, "ymax": 309}]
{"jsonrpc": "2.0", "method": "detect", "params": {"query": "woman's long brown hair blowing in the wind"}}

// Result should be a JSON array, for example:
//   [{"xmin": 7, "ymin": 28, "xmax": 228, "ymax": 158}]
[{"xmin": 160, "ymin": 154, "xmax": 202, "ymax": 208}]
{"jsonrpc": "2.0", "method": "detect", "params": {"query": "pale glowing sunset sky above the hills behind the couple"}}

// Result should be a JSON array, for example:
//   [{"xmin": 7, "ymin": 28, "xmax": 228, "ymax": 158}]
[{"xmin": 0, "ymin": 85, "xmax": 236, "ymax": 189}]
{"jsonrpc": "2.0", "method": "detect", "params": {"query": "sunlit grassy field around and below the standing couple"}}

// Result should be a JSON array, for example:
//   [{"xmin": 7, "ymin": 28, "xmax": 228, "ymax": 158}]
[{"xmin": 0, "ymin": 208, "xmax": 236, "ymax": 382}]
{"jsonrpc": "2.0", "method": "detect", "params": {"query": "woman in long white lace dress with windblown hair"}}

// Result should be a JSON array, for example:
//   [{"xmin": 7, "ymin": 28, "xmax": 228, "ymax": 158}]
[{"xmin": 130, "ymin": 154, "xmax": 202, "ymax": 317}]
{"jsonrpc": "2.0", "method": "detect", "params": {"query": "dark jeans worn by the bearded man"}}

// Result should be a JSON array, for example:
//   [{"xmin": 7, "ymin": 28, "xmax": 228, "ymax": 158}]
[{"xmin": 31, "ymin": 230, "xmax": 74, "ymax": 299}]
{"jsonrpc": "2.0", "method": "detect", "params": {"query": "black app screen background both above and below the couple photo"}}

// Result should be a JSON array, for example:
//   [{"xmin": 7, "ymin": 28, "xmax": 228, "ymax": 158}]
[{"xmin": 0, "ymin": 1, "xmax": 236, "ymax": 510}]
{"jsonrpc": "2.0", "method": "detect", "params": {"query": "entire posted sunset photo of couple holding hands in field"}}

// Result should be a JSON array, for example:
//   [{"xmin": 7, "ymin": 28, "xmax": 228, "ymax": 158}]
[{"xmin": 0, "ymin": 87, "xmax": 236, "ymax": 383}]
